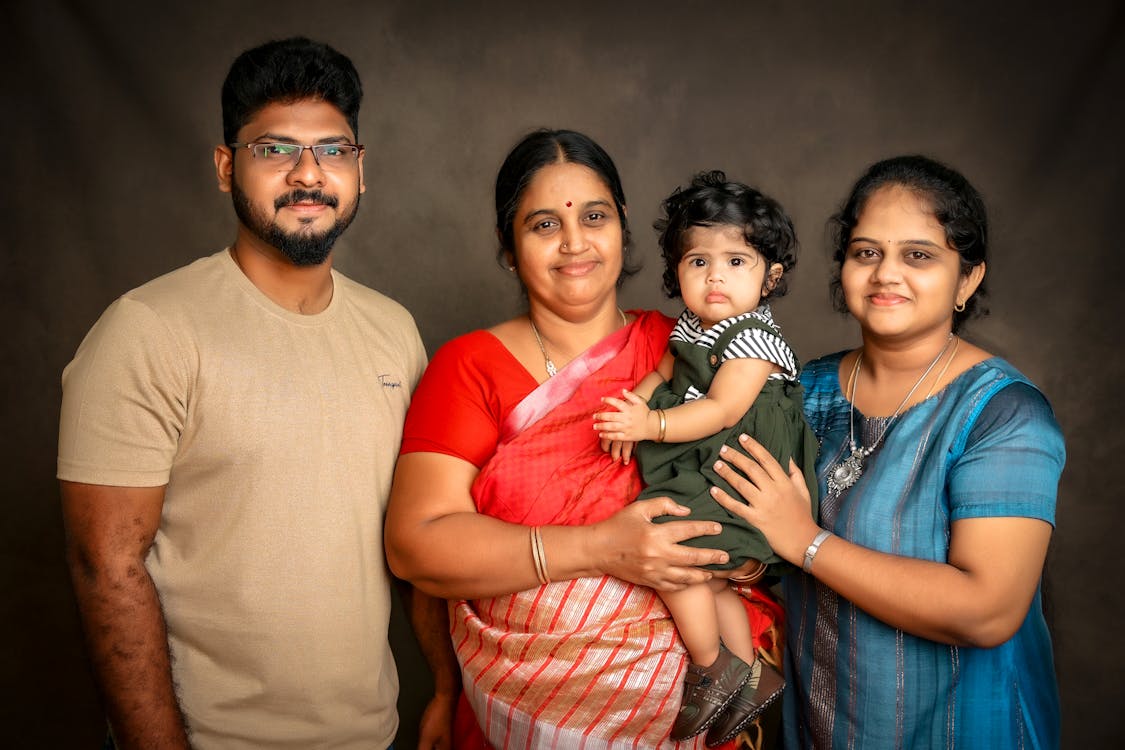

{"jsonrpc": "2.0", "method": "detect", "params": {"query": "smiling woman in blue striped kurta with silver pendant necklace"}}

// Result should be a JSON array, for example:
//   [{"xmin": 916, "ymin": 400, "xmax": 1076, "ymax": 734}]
[{"xmin": 713, "ymin": 156, "xmax": 1064, "ymax": 749}]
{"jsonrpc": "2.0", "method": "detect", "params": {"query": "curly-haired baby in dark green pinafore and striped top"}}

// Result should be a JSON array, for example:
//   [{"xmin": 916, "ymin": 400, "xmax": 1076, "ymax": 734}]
[{"xmin": 594, "ymin": 171, "xmax": 817, "ymax": 746}]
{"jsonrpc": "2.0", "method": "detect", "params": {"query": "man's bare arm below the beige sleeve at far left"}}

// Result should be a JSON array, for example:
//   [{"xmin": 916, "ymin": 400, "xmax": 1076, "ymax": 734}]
[{"xmin": 61, "ymin": 481, "xmax": 189, "ymax": 750}]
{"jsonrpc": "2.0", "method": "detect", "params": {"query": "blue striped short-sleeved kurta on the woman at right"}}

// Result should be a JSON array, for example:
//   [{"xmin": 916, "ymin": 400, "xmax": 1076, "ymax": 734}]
[{"xmin": 783, "ymin": 352, "xmax": 1065, "ymax": 750}]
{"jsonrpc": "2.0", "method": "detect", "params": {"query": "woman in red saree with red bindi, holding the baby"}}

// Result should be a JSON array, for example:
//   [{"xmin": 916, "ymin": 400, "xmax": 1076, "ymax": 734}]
[{"xmin": 386, "ymin": 130, "xmax": 776, "ymax": 749}]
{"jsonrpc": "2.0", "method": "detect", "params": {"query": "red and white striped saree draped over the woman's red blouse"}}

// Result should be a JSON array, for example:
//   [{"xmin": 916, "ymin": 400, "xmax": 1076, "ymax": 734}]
[{"xmin": 450, "ymin": 317, "xmax": 772, "ymax": 749}]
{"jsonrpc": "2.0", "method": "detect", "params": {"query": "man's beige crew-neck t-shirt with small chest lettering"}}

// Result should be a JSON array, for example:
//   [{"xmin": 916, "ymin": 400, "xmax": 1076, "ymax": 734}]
[{"xmin": 59, "ymin": 251, "xmax": 425, "ymax": 750}]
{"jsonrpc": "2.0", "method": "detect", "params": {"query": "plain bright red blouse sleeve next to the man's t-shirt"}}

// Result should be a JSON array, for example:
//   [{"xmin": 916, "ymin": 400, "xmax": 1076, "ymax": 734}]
[{"xmin": 401, "ymin": 333, "xmax": 500, "ymax": 468}]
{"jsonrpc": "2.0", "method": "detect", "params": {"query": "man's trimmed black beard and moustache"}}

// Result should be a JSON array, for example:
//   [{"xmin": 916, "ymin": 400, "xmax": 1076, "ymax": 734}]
[{"xmin": 231, "ymin": 179, "xmax": 359, "ymax": 265}]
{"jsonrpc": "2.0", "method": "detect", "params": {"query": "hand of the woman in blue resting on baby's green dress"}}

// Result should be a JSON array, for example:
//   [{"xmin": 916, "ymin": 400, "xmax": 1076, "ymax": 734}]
[{"xmin": 711, "ymin": 435, "xmax": 819, "ymax": 566}]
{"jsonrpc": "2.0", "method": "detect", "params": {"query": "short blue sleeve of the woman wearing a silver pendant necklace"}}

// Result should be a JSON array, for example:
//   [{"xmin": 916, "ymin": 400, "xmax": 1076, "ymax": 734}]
[{"xmin": 950, "ymin": 382, "xmax": 1067, "ymax": 525}]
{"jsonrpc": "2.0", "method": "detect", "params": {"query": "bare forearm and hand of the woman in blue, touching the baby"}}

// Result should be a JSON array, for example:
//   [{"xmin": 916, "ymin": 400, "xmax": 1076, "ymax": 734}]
[{"xmin": 711, "ymin": 435, "xmax": 1052, "ymax": 648}]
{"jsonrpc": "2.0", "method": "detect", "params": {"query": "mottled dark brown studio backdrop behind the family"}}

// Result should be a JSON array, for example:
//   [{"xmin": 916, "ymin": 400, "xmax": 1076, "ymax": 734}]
[{"xmin": 0, "ymin": 0, "xmax": 1125, "ymax": 748}]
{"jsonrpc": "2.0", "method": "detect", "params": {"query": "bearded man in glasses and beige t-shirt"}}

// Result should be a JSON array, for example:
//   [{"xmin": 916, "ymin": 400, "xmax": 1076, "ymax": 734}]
[{"xmin": 59, "ymin": 38, "xmax": 448, "ymax": 750}]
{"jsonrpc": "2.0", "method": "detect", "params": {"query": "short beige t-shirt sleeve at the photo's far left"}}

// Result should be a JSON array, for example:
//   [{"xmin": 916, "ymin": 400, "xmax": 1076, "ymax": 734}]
[{"xmin": 59, "ymin": 297, "xmax": 188, "ymax": 487}]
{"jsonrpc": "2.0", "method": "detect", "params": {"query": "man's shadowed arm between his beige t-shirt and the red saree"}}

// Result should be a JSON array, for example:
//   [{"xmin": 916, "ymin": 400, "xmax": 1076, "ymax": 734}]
[{"xmin": 401, "ymin": 581, "xmax": 461, "ymax": 750}]
